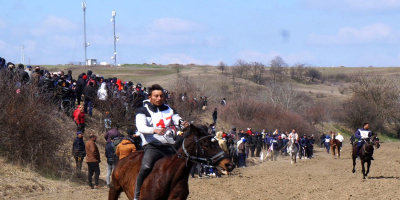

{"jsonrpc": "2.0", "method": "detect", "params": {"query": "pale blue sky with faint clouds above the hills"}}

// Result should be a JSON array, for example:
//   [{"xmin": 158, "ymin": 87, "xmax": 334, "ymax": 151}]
[{"xmin": 0, "ymin": 0, "xmax": 400, "ymax": 67}]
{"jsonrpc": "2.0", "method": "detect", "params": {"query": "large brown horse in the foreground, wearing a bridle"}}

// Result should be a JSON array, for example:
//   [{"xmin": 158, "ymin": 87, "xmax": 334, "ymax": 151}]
[{"xmin": 108, "ymin": 125, "xmax": 234, "ymax": 200}]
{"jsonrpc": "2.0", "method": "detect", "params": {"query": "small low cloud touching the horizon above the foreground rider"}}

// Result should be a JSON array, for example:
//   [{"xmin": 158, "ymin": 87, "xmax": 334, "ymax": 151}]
[{"xmin": 148, "ymin": 53, "xmax": 203, "ymax": 65}]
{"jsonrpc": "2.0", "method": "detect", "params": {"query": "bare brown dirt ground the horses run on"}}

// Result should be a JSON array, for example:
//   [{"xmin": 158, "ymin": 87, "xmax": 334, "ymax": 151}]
[{"xmin": 0, "ymin": 142, "xmax": 400, "ymax": 200}]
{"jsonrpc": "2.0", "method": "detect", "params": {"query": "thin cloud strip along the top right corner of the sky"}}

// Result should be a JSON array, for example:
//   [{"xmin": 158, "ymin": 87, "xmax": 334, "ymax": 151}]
[{"xmin": 303, "ymin": 0, "xmax": 400, "ymax": 11}]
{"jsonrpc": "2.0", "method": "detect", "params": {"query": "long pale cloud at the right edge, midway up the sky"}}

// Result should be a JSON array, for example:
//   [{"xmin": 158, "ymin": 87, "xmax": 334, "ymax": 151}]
[{"xmin": 308, "ymin": 24, "xmax": 400, "ymax": 45}]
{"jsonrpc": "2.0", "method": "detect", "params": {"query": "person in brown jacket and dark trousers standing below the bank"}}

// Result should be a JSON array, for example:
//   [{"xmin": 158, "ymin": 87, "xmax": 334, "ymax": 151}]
[{"xmin": 85, "ymin": 134, "xmax": 101, "ymax": 189}]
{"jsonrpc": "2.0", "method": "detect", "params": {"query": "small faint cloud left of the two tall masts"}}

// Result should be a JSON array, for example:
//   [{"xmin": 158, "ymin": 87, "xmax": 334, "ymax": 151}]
[{"xmin": 32, "ymin": 16, "xmax": 78, "ymax": 36}]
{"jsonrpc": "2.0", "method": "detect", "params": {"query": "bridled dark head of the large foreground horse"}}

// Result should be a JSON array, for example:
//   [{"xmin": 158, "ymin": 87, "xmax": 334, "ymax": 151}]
[{"xmin": 182, "ymin": 124, "xmax": 235, "ymax": 172}]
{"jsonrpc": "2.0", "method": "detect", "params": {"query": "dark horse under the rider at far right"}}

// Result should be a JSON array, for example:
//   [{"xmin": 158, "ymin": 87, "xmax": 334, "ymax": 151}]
[{"xmin": 352, "ymin": 135, "xmax": 380, "ymax": 179}]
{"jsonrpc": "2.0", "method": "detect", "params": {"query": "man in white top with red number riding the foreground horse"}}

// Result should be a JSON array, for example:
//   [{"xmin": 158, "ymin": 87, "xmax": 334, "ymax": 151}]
[{"xmin": 134, "ymin": 84, "xmax": 188, "ymax": 200}]
